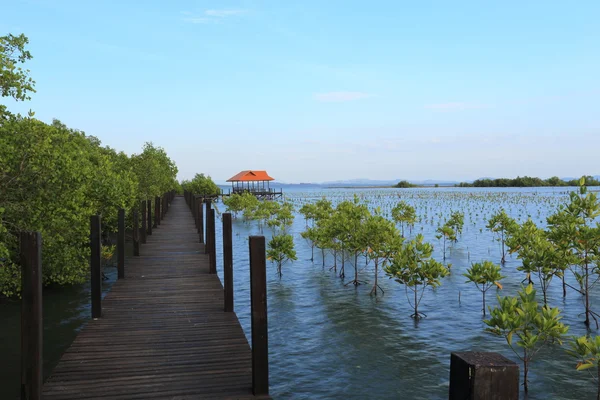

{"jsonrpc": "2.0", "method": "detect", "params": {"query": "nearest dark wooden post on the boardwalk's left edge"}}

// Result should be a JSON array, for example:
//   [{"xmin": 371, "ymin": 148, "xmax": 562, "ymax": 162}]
[{"xmin": 20, "ymin": 232, "xmax": 44, "ymax": 400}]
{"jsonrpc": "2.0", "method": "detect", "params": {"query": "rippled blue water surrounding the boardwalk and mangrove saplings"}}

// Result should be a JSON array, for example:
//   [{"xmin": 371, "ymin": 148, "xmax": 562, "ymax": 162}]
[{"xmin": 0, "ymin": 188, "xmax": 599, "ymax": 399}]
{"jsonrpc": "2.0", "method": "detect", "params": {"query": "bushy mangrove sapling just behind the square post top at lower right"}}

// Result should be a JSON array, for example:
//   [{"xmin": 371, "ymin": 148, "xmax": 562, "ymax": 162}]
[{"xmin": 483, "ymin": 284, "xmax": 569, "ymax": 394}]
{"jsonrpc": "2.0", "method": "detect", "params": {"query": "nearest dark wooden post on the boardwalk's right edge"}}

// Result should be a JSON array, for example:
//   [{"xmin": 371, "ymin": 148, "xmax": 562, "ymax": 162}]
[{"xmin": 250, "ymin": 236, "xmax": 269, "ymax": 396}]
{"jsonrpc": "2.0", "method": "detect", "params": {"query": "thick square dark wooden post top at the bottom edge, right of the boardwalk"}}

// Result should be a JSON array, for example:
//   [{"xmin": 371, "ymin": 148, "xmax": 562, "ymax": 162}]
[{"xmin": 449, "ymin": 351, "xmax": 519, "ymax": 400}]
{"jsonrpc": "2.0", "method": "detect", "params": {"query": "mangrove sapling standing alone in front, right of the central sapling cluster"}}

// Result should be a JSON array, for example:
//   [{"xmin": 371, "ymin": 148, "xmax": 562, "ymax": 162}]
[{"xmin": 384, "ymin": 234, "xmax": 450, "ymax": 320}]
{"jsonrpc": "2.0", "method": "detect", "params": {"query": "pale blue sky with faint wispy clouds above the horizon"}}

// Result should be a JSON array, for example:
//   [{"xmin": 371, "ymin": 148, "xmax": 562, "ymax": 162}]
[{"xmin": 0, "ymin": 0, "xmax": 600, "ymax": 182}]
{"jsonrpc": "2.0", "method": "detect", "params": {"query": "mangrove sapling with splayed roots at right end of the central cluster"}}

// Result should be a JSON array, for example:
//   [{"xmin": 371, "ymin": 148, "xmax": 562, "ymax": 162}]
[{"xmin": 363, "ymin": 215, "xmax": 402, "ymax": 296}]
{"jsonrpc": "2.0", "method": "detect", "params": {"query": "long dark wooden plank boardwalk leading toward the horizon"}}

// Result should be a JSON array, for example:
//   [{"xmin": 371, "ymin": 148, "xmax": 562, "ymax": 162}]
[{"xmin": 43, "ymin": 197, "xmax": 268, "ymax": 400}]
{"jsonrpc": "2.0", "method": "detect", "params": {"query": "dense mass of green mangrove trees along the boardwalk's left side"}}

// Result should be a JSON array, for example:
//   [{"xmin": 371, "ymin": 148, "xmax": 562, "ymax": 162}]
[{"xmin": 0, "ymin": 116, "xmax": 174, "ymax": 296}]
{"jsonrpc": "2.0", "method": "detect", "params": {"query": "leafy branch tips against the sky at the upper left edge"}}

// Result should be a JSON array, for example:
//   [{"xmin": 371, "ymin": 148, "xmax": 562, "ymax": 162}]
[{"xmin": 0, "ymin": 34, "xmax": 35, "ymax": 120}]
